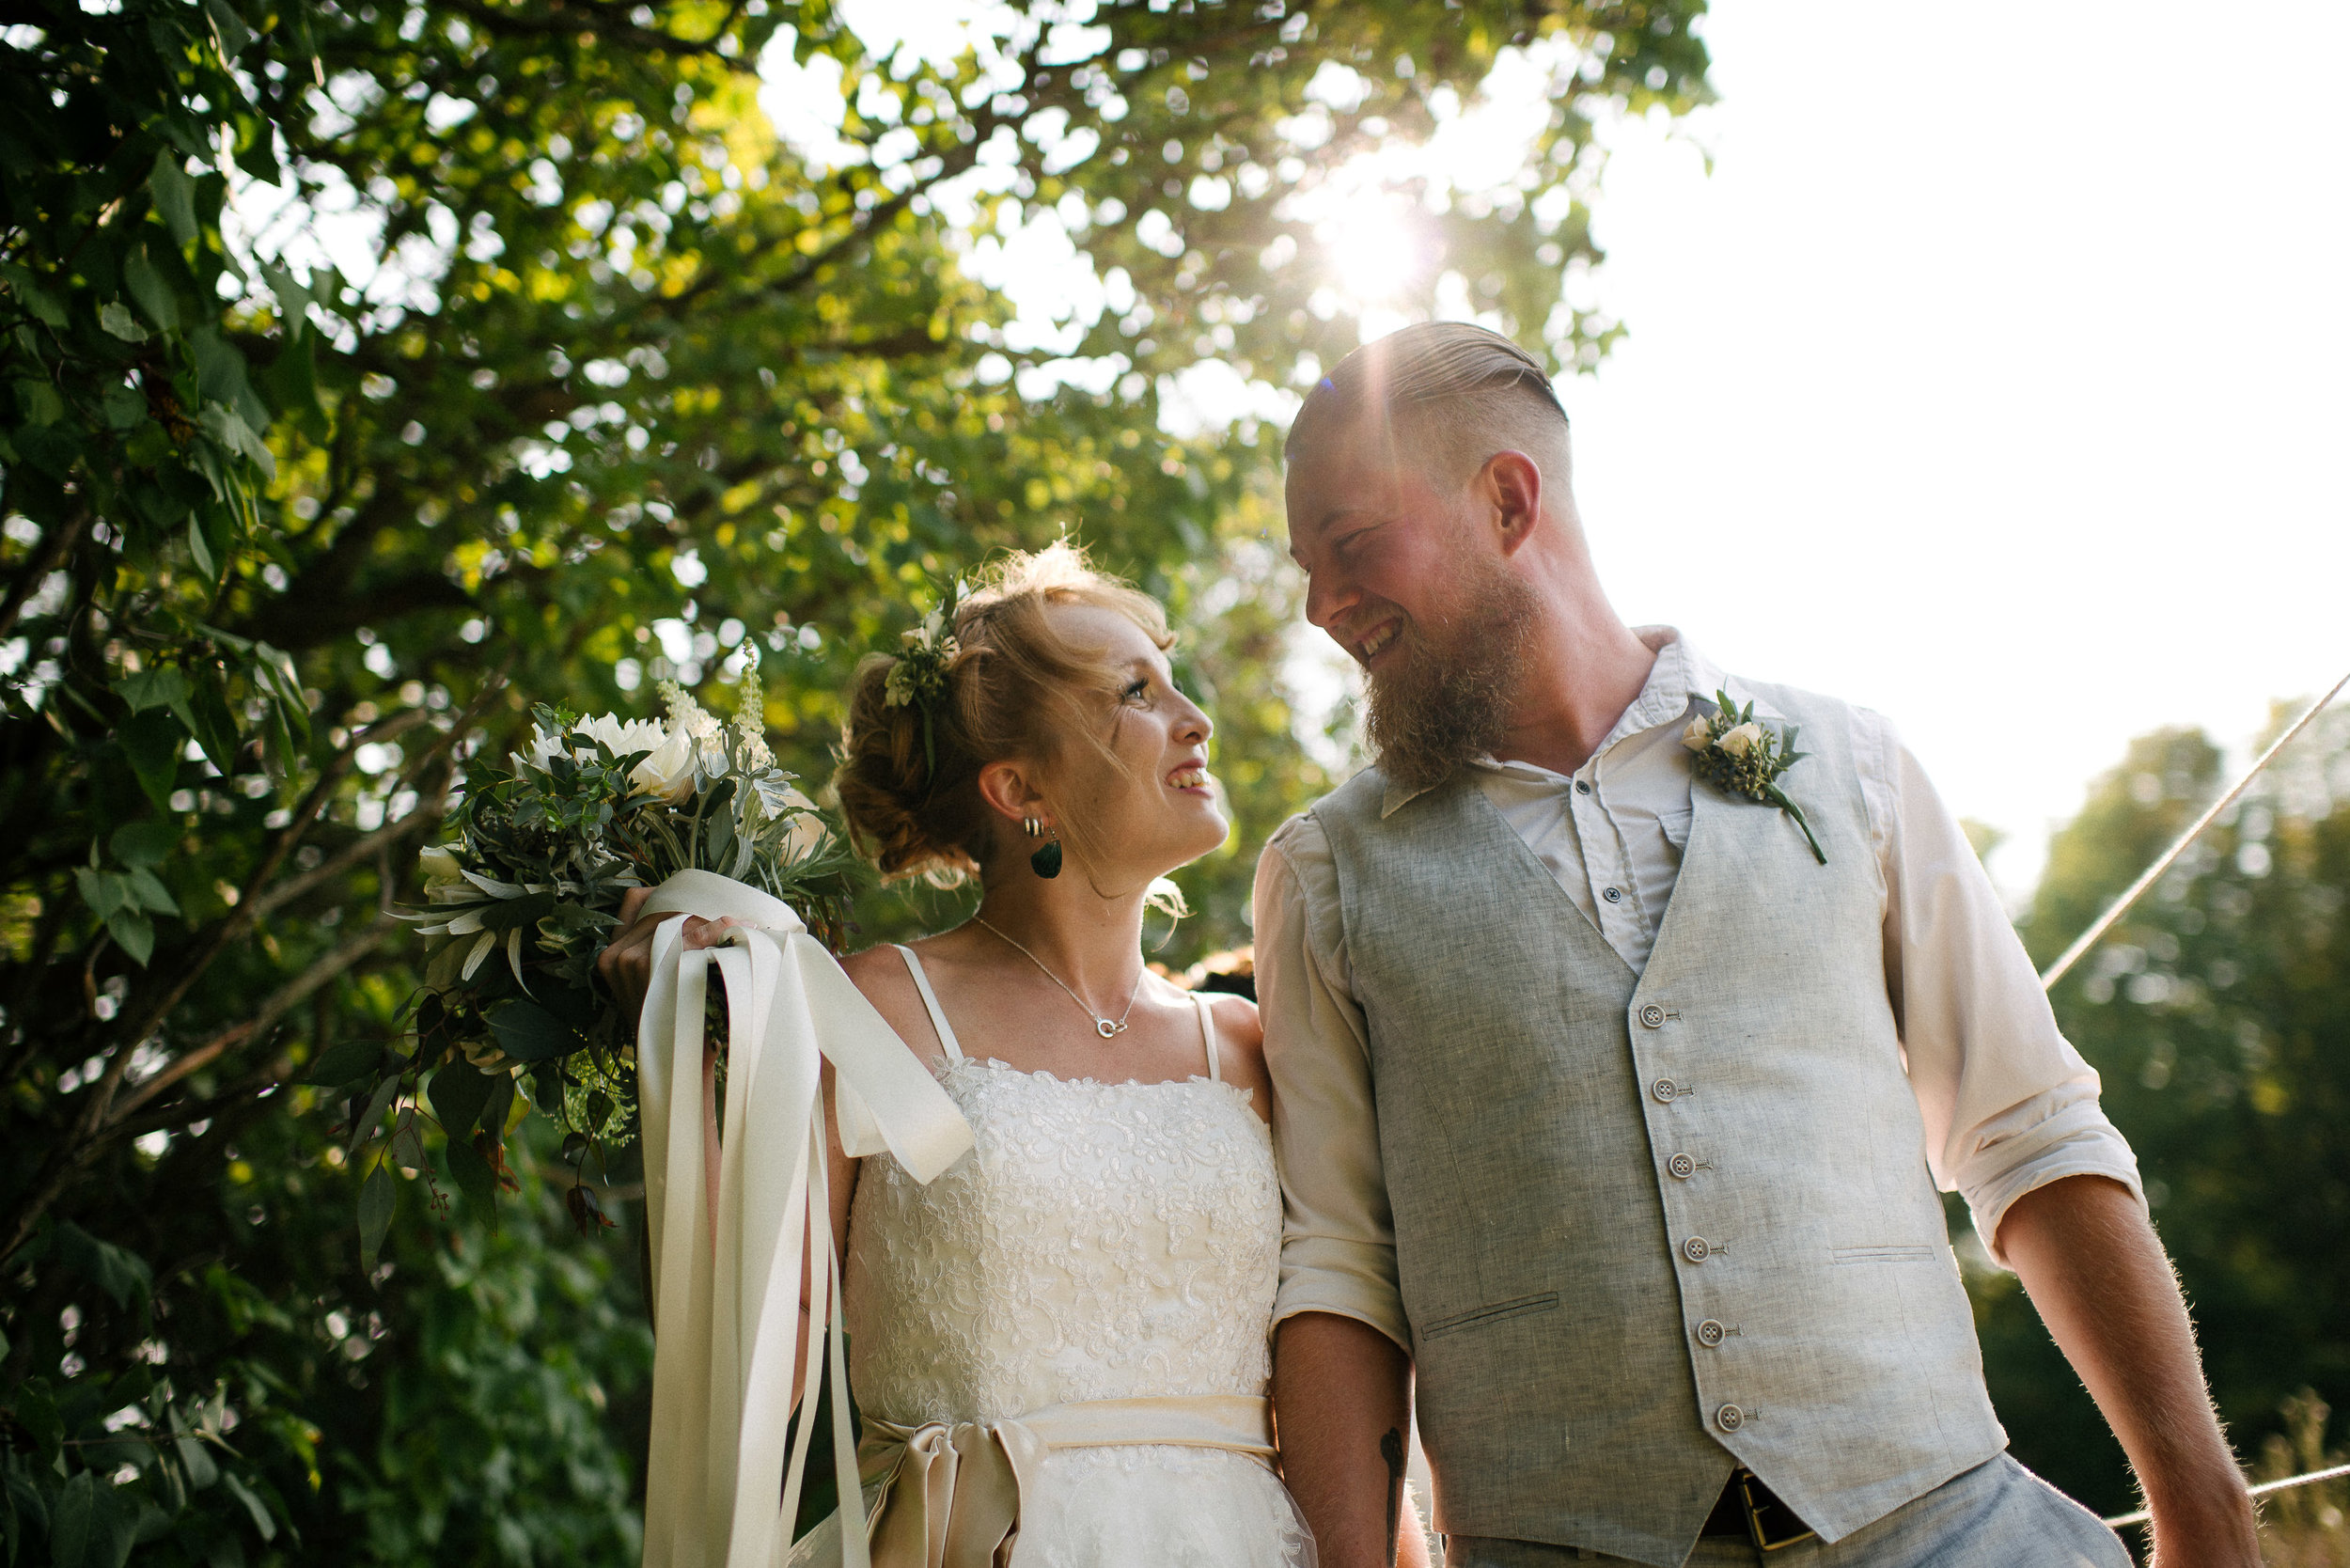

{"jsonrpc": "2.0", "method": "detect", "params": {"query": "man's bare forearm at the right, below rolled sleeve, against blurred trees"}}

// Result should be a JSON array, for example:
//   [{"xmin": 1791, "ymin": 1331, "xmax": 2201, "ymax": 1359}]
[{"xmin": 2000, "ymin": 1175, "xmax": 2261, "ymax": 1568}]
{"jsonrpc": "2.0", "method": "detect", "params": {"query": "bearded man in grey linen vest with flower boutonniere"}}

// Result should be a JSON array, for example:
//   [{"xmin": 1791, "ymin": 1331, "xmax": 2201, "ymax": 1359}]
[{"xmin": 1258, "ymin": 324, "xmax": 2259, "ymax": 1568}]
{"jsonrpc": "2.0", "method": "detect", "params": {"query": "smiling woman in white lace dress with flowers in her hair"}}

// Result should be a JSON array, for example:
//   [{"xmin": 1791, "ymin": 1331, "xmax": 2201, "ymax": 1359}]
[{"xmin": 604, "ymin": 545, "xmax": 1314, "ymax": 1568}]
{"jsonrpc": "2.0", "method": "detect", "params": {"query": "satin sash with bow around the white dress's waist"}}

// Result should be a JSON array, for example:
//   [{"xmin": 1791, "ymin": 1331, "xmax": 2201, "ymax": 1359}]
[{"xmin": 849, "ymin": 1394, "xmax": 1274, "ymax": 1568}]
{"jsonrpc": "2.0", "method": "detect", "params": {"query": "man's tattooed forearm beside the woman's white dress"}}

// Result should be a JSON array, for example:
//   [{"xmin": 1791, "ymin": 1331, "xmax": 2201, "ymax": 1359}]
[{"xmin": 1274, "ymin": 1311, "xmax": 1427, "ymax": 1568}]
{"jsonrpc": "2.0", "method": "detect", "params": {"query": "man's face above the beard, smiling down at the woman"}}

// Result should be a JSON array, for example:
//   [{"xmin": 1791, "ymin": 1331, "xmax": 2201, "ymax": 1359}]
[{"xmin": 1288, "ymin": 421, "xmax": 1493, "ymax": 680}]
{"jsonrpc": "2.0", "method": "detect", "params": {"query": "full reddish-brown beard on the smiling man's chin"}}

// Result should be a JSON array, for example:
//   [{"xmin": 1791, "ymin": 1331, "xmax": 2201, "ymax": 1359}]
[{"xmin": 1363, "ymin": 564, "xmax": 1537, "ymax": 790}]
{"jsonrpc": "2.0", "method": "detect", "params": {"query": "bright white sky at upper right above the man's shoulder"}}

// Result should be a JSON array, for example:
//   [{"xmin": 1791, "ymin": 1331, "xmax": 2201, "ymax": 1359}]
[{"xmin": 769, "ymin": 0, "xmax": 2350, "ymax": 891}]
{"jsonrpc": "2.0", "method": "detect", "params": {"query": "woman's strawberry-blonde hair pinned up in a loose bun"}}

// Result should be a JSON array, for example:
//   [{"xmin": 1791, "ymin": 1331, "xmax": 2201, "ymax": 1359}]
[{"xmin": 832, "ymin": 541, "xmax": 1175, "ymax": 886}]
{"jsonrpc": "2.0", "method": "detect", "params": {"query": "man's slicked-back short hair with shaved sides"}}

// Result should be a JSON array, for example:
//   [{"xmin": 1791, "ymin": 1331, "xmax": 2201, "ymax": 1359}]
[{"xmin": 1281, "ymin": 322, "xmax": 1568, "ymax": 484}]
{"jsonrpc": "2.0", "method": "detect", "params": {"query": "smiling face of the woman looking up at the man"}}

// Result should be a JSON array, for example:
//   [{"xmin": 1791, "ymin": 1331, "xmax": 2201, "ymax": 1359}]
[{"xmin": 1051, "ymin": 604, "xmax": 1230, "ymax": 888}]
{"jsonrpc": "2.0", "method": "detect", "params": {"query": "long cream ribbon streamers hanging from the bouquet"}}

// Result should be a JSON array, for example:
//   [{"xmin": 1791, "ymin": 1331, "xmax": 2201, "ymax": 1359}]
[{"xmin": 637, "ymin": 872, "xmax": 971, "ymax": 1568}]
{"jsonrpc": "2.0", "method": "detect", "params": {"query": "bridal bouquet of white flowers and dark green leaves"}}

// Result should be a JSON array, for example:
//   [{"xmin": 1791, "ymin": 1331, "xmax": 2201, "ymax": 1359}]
[{"xmin": 376, "ymin": 658, "xmax": 854, "ymax": 1234}]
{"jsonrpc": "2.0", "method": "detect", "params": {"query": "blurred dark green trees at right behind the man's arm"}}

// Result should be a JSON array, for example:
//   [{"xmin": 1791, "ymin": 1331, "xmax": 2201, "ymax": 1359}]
[{"xmin": 1977, "ymin": 710, "xmax": 2350, "ymax": 1513}]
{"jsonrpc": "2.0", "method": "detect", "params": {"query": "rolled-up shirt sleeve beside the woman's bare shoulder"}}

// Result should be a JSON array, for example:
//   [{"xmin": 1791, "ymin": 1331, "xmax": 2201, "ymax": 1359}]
[{"xmin": 1255, "ymin": 818, "xmax": 1413, "ymax": 1354}]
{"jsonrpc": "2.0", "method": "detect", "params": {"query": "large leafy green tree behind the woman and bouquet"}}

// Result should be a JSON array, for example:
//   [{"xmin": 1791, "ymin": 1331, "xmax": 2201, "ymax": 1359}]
[{"xmin": 0, "ymin": 0, "xmax": 1706, "ymax": 1560}]
